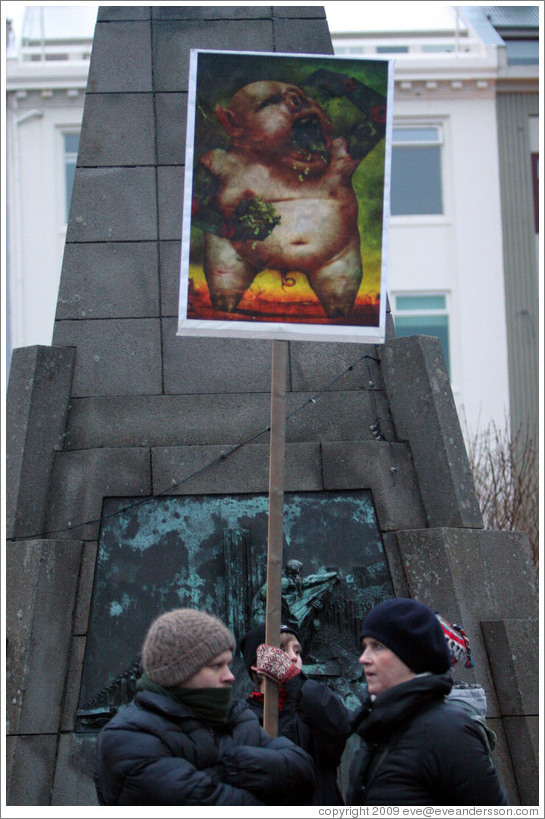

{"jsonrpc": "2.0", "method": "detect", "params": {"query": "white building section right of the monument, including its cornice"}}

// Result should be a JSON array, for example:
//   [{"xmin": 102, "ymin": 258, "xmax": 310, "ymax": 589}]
[{"xmin": 334, "ymin": 8, "xmax": 509, "ymax": 442}]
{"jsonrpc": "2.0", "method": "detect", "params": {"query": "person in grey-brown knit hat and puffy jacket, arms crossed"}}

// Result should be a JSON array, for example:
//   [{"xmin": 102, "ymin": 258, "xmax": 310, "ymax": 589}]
[{"xmin": 95, "ymin": 608, "xmax": 314, "ymax": 806}]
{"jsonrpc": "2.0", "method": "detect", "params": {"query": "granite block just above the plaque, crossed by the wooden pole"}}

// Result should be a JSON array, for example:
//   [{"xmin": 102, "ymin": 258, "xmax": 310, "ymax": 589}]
[{"xmin": 152, "ymin": 442, "xmax": 323, "ymax": 495}]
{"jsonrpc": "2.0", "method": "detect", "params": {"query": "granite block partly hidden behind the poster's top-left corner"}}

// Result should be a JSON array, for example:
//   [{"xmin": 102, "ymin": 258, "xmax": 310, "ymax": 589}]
[{"xmin": 153, "ymin": 19, "xmax": 273, "ymax": 92}]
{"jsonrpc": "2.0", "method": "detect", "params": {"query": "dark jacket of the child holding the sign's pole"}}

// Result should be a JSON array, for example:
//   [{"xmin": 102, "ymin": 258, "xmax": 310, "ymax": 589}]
[{"xmin": 248, "ymin": 672, "xmax": 352, "ymax": 805}]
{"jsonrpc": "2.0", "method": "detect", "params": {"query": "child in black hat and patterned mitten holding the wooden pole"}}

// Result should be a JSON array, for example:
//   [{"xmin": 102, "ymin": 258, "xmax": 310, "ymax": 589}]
[{"xmin": 239, "ymin": 623, "xmax": 351, "ymax": 805}]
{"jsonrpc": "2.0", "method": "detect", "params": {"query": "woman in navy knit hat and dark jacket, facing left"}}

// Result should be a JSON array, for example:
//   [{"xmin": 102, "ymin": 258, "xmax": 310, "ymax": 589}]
[{"xmin": 346, "ymin": 598, "xmax": 507, "ymax": 806}]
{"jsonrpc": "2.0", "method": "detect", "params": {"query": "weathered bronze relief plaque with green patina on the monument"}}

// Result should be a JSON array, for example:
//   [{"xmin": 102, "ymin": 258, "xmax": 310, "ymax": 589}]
[{"xmin": 76, "ymin": 490, "xmax": 394, "ymax": 731}]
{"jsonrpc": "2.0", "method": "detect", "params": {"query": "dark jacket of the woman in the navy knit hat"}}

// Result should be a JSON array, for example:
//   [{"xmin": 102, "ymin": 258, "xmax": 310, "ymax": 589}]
[{"xmin": 347, "ymin": 674, "xmax": 507, "ymax": 805}]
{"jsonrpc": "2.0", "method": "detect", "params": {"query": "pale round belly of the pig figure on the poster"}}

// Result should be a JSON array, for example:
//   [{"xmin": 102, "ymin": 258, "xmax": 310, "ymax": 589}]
[{"xmin": 237, "ymin": 198, "xmax": 358, "ymax": 272}]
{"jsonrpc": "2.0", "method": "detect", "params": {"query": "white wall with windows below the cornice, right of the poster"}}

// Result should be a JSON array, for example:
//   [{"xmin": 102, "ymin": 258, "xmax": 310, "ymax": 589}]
[{"xmin": 388, "ymin": 78, "xmax": 509, "ymax": 442}]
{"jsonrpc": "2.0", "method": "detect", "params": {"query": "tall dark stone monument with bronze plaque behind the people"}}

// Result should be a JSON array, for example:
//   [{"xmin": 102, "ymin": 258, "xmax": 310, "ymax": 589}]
[{"xmin": 6, "ymin": 6, "xmax": 538, "ymax": 805}]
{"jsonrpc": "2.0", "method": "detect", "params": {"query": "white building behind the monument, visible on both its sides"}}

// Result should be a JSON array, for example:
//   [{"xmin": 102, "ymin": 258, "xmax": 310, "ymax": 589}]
[{"xmin": 7, "ymin": 3, "xmax": 537, "ymax": 436}]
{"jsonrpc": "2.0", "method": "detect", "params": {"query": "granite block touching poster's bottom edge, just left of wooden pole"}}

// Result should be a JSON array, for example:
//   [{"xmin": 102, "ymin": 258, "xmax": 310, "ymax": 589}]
[{"xmin": 162, "ymin": 318, "xmax": 272, "ymax": 394}]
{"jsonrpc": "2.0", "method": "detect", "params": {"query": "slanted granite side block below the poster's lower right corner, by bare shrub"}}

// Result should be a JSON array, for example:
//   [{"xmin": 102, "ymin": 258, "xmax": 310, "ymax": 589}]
[{"xmin": 381, "ymin": 336, "xmax": 483, "ymax": 528}]
